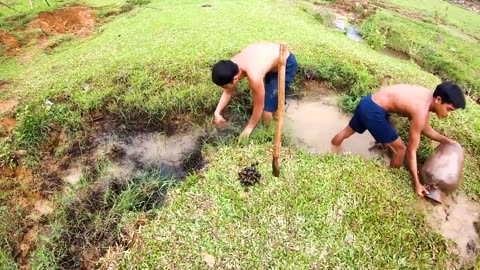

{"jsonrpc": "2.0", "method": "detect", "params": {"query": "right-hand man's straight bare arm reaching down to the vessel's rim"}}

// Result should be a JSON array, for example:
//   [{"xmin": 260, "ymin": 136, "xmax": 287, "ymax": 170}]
[{"xmin": 407, "ymin": 117, "xmax": 427, "ymax": 196}]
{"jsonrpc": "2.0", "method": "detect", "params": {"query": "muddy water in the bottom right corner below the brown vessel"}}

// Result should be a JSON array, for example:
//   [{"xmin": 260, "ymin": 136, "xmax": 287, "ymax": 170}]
[{"xmin": 418, "ymin": 194, "xmax": 480, "ymax": 265}]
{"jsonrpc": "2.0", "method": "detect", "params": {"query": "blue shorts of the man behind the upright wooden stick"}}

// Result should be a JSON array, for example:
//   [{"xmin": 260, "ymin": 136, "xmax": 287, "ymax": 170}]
[{"xmin": 263, "ymin": 52, "xmax": 297, "ymax": 112}]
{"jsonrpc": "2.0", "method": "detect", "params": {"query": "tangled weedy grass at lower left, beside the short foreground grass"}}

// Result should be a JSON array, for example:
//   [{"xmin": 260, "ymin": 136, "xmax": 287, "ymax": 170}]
[{"xmin": 30, "ymin": 160, "xmax": 175, "ymax": 269}]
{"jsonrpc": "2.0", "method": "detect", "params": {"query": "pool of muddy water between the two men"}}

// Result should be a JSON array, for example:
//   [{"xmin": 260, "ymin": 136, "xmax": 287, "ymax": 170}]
[{"xmin": 285, "ymin": 85, "xmax": 388, "ymax": 163}]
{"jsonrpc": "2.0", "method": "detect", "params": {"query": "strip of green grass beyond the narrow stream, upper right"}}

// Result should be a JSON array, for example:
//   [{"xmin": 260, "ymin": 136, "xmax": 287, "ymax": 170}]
[{"xmin": 362, "ymin": 11, "xmax": 480, "ymax": 100}]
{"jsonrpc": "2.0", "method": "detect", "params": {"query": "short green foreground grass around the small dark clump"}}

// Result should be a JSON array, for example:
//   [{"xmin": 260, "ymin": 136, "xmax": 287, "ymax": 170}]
[{"xmin": 120, "ymin": 143, "xmax": 452, "ymax": 269}]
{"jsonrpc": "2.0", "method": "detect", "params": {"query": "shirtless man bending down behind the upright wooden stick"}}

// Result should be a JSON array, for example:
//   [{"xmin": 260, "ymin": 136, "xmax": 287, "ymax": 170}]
[{"xmin": 212, "ymin": 42, "xmax": 297, "ymax": 137}]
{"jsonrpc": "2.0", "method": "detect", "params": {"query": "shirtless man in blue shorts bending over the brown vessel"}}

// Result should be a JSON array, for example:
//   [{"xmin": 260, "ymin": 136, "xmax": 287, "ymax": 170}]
[{"xmin": 332, "ymin": 82, "xmax": 465, "ymax": 197}]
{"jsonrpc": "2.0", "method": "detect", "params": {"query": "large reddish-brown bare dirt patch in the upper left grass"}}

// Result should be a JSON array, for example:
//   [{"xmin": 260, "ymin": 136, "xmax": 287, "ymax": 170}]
[{"xmin": 28, "ymin": 6, "xmax": 96, "ymax": 37}]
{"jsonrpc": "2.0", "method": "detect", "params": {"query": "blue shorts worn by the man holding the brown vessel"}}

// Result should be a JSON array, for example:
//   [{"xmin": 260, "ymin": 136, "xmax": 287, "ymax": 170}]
[{"xmin": 348, "ymin": 95, "xmax": 398, "ymax": 143}]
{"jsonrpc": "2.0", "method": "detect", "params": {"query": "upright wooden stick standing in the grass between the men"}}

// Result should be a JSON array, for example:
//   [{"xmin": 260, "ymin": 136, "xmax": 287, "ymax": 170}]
[{"xmin": 272, "ymin": 43, "xmax": 288, "ymax": 177}]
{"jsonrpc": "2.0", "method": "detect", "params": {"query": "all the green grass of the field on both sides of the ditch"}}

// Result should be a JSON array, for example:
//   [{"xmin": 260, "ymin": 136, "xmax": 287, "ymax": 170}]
[{"xmin": 0, "ymin": 0, "xmax": 480, "ymax": 269}]
